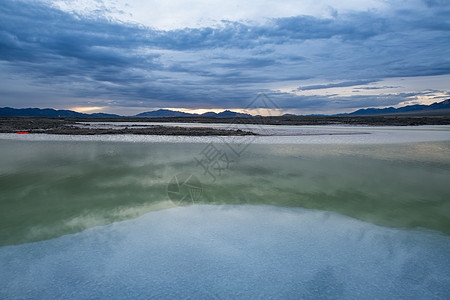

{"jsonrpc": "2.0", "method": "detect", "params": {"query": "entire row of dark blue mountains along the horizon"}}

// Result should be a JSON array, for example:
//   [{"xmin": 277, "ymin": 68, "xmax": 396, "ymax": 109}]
[{"xmin": 0, "ymin": 99, "xmax": 450, "ymax": 118}]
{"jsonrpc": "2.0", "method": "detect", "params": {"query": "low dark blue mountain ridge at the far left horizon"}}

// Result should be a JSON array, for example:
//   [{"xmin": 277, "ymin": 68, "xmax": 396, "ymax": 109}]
[{"xmin": 0, "ymin": 107, "xmax": 120, "ymax": 118}]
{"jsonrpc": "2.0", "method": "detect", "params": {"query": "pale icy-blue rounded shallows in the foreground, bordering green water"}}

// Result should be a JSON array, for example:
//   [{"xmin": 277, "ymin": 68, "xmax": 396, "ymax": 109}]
[{"xmin": 0, "ymin": 205, "xmax": 450, "ymax": 299}]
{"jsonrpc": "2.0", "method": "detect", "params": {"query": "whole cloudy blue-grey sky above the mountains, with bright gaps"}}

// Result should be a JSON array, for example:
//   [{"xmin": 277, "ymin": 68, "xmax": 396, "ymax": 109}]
[{"xmin": 0, "ymin": 0, "xmax": 450, "ymax": 115}]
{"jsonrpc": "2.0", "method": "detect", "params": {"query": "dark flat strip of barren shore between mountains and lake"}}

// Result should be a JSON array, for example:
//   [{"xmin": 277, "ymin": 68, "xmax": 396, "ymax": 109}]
[{"xmin": 0, "ymin": 116, "xmax": 450, "ymax": 136}]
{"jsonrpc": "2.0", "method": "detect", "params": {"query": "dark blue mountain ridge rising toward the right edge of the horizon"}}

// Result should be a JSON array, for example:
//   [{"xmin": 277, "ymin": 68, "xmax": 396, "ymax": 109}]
[{"xmin": 345, "ymin": 99, "xmax": 450, "ymax": 116}]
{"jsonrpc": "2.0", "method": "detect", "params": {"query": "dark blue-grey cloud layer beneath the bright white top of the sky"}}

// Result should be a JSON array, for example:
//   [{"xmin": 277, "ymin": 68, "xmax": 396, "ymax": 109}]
[{"xmin": 0, "ymin": 0, "xmax": 450, "ymax": 108}]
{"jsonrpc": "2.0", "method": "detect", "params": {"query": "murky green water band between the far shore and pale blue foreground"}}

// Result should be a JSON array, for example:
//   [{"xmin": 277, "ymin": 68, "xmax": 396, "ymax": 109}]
[{"xmin": 0, "ymin": 140, "xmax": 450, "ymax": 245}]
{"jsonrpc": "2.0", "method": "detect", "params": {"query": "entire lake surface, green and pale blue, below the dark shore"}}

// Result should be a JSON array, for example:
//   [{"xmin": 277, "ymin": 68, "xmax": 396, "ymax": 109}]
[{"xmin": 0, "ymin": 126, "xmax": 450, "ymax": 299}]
